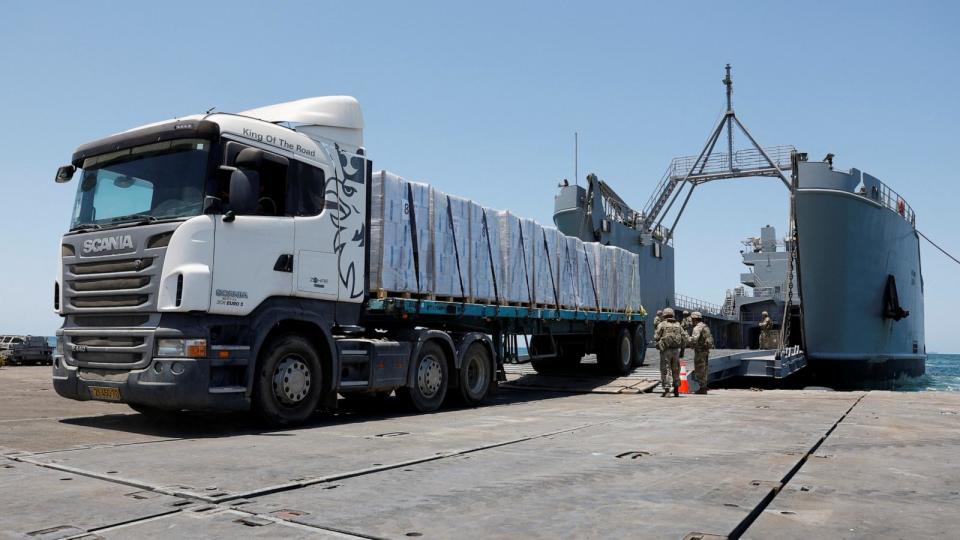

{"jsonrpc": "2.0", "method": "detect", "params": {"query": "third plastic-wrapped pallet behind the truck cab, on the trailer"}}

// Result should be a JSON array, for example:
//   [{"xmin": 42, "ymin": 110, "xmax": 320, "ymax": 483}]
[{"xmin": 467, "ymin": 201, "xmax": 503, "ymax": 302}]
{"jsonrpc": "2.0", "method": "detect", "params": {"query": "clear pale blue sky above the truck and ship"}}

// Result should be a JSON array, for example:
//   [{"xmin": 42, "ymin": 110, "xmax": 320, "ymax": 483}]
[{"xmin": 0, "ymin": 1, "xmax": 960, "ymax": 352}]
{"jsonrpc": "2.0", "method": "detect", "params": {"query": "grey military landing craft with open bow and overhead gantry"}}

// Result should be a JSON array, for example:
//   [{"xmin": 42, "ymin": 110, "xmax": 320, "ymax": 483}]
[{"xmin": 554, "ymin": 65, "xmax": 926, "ymax": 387}]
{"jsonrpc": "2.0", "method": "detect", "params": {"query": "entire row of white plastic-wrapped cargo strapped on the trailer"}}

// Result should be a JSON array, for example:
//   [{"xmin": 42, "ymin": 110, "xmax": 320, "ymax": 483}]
[{"xmin": 370, "ymin": 171, "xmax": 640, "ymax": 312}]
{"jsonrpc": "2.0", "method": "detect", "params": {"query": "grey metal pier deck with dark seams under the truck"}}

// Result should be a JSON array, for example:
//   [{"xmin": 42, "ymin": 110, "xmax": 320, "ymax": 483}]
[{"xmin": 0, "ymin": 367, "xmax": 960, "ymax": 540}]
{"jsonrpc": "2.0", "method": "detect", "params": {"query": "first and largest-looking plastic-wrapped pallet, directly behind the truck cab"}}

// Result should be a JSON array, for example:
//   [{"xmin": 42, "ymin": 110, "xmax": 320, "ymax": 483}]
[{"xmin": 370, "ymin": 171, "xmax": 433, "ymax": 293}]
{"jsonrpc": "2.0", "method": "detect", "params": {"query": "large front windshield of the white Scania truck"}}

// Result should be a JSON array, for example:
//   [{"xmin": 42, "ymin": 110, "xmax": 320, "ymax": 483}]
[{"xmin": 70, "ymin": 139, "xmax": 210, "ymax": 229}]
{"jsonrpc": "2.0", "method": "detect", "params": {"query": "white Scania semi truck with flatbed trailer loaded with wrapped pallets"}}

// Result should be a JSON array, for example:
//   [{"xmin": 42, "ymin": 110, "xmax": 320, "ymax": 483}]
[{"xmin": 53, "ymin": 96, "xmax": 646, "ymax": 425}]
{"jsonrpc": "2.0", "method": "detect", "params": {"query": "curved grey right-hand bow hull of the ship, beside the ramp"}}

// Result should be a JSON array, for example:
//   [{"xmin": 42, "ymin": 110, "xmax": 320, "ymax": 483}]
[{"xmin": 796, "ymin": 188, "xmax": 926, "ymax": 387}]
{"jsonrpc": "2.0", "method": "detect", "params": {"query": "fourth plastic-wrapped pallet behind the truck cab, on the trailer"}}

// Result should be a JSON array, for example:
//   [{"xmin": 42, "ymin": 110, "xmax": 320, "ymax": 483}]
[{"xmin": 498, "ymin": 211, "xmax": 533, "ymax": 303}]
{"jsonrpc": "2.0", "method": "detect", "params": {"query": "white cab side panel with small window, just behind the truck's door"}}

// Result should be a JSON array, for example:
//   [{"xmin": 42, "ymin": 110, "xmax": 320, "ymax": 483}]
[{"xmin": 290, "ymin": 161, "xmax": 339, "ymax": 301}]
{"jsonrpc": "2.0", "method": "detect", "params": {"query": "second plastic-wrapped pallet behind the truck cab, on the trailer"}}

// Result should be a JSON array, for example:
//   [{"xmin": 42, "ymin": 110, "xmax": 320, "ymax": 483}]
[{"xmin": 431, "ymin": 189, "xmax": 470, "ymax": 297}]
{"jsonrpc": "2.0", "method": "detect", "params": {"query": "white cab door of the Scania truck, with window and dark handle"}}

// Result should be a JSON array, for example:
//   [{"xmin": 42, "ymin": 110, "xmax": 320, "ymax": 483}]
[{"xmin": 210, "ymin": 141, "xmax": 294, "ymax": 315}]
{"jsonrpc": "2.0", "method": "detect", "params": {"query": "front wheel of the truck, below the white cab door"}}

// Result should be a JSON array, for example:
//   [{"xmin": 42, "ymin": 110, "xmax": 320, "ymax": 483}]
[{"xmin": 253, "ymin": 334, "xmax": 324, "ymax": 426}]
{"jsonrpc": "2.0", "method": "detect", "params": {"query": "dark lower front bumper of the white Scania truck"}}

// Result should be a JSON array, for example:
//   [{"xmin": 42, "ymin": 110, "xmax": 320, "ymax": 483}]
[{"xmin": 53, "ymin": 355, "xmax": 250, "ymax": 411}]
